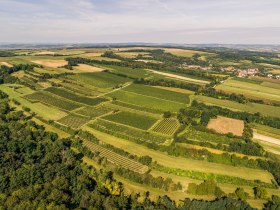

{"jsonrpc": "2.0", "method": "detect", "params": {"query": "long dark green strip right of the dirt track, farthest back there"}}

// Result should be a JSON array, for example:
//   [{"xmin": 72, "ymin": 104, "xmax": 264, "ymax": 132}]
[{"xmin": 123, "ymin": 84, "xmax": 190, "ymax": 104}]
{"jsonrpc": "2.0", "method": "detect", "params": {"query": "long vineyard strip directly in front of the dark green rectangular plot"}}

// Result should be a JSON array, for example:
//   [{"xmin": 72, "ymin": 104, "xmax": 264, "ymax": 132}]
[{"xmin": 89, "ymin": 119, "xmax": 166, "ymax": 144}]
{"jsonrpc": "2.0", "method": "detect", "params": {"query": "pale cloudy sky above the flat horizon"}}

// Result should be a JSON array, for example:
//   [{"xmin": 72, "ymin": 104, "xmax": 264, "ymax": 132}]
[{"xmin": 0, "ymin": 0, "xmax": 280, "ymax": 44}]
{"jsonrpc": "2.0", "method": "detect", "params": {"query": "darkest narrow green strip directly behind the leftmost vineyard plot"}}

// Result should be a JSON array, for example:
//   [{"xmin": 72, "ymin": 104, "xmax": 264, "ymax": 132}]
[{"xmin": 45, "ymin": 87, "xmax": 107, "ymax": 106}]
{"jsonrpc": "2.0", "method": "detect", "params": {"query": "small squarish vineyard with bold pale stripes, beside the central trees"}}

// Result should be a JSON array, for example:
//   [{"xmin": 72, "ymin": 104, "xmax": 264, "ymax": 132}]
[{"xmin": 153, "ymin": 118, "xmax": 180, "ymax": 135}]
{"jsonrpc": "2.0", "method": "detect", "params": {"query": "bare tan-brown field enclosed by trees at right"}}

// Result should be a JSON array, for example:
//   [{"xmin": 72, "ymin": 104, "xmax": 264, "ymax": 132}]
[{"xmin": 207, "ymin": 116, "xmax": 244, "ymax": 136}]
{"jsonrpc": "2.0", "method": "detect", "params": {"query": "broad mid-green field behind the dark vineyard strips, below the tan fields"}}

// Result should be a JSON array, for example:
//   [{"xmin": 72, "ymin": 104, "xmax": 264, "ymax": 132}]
[{"xmin": 69, "ymin": 72, "xmax": 131, "ymax": 88}]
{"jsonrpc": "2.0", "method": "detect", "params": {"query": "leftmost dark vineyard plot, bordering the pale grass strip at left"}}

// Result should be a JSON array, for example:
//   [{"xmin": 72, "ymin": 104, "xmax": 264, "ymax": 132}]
[{"xmin": 24, "ymin": 91, "xmax": 81, "ymax": 111}]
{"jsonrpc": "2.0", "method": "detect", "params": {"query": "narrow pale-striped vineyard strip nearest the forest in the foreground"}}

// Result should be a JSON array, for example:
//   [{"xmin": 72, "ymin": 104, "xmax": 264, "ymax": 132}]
[{"xmin": 83, "ymin": 140, "xmax": 149, "ymax": 174}]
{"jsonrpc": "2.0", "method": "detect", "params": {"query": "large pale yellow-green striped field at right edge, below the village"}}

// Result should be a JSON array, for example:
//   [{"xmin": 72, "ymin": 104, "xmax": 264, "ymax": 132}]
[{"xmin": 216, "ymin": 79, "xmax": 280, "ymax": 103}]
